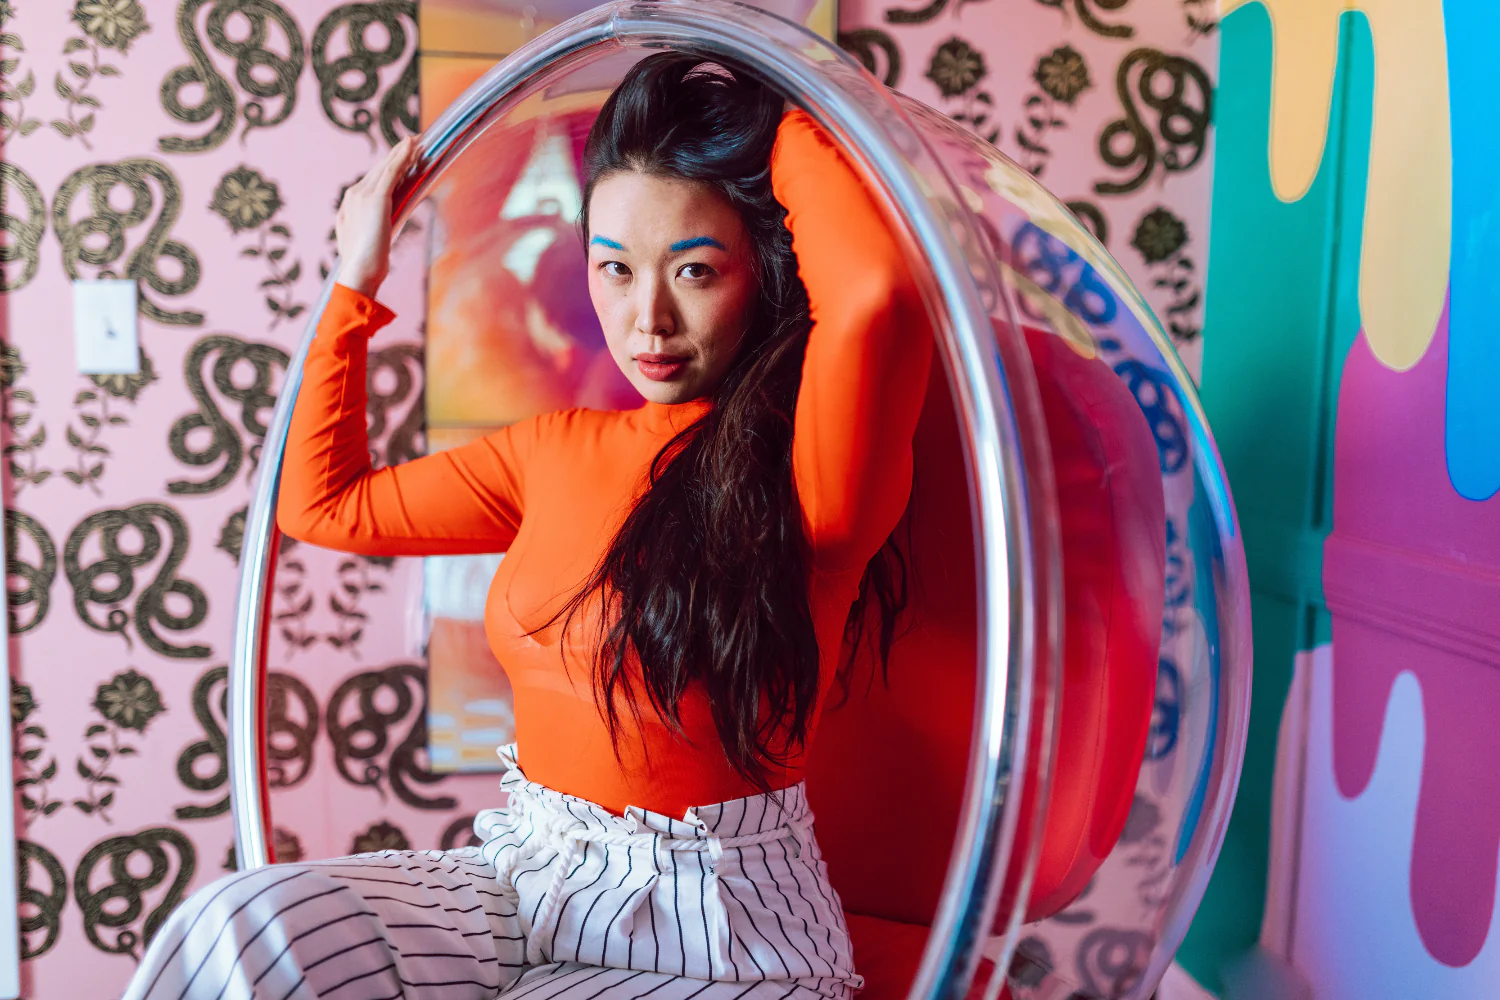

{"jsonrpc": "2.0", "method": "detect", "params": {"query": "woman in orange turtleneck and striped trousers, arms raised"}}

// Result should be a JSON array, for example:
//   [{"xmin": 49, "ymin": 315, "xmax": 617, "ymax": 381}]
[{"xmin": 126, "ymin": 54, "xmax": 932, "ymax": 1000}]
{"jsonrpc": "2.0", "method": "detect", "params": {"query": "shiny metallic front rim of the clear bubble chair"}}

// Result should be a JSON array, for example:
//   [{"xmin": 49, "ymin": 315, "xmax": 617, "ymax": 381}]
[{"xmin": 228, "ymin": 7, "xmax": 1058, "ymax": 1000}]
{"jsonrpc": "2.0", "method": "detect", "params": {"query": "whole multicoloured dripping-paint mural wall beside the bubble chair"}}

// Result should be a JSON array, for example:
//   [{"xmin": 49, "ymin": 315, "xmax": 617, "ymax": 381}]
[{"xmin": 1184, "ymin": 0, "xmax": 1500, "ymax": 1000}]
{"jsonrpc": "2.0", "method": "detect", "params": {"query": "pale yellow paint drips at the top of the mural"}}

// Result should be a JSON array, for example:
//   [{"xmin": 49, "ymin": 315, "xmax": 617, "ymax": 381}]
[{"xmin": 1223, "ymin": 0, "xmax": 1454, "ymax": 372}]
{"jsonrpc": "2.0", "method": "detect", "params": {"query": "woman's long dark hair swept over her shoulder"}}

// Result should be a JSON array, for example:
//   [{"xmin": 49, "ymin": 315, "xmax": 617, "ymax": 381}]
[{"xmin": 554, "ymin": 52, "xmax": 906, "ymax": 790}]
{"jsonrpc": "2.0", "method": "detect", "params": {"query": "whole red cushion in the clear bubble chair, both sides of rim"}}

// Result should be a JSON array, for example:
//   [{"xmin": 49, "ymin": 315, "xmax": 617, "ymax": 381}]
[{"xmin": 809, "ymin": 322, "xmax": 1166, "ymax": 941}]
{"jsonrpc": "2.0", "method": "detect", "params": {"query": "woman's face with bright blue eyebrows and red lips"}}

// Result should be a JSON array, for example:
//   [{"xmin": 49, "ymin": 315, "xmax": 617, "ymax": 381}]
[{"xmin": 588, "ymin": 171, "xmax": 759, "ymax": 403}]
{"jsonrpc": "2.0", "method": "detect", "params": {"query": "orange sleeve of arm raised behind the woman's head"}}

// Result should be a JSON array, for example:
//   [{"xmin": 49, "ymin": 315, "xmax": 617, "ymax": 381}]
[{"xmin": 771, "ymin": 111, "xmax": 933, "ymax": 573}]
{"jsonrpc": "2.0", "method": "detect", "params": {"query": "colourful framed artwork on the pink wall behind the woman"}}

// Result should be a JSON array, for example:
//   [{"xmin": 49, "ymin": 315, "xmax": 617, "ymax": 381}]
[{"xmin": 419, "ymin": 0, "xmax": 839, "ymax": 771}]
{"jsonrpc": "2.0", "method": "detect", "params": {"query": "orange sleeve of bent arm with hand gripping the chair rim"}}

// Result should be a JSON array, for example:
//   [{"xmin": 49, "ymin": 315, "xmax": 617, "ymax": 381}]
[{"xmin": 276, "ymin": 285, "xmax": 539, "ymax": 556}]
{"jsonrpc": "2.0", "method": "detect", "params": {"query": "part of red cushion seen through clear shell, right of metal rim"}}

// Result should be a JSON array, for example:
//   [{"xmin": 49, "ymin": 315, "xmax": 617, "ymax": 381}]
[{"xmin": 1008, "ymin": 330, "xmax": 1167, "ymax": 921}]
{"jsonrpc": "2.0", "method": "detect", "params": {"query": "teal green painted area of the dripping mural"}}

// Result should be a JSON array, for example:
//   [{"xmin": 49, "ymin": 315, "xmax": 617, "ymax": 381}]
[{"xmin": 1178, "ymin": 4, "xmax": 1374, "ymax": 991}]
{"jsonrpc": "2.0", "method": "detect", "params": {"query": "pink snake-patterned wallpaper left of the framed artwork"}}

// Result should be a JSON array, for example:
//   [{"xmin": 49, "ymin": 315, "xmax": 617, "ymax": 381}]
[{"xmin": 0, "ymin": 0, "xmax": 495, "ymax": 1000}]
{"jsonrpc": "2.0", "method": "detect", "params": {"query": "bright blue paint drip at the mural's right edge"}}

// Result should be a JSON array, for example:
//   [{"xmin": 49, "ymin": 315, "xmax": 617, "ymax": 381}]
[{"xmin": 1443, "ymin": 0, "xmax": 1500, "ymax": 501}]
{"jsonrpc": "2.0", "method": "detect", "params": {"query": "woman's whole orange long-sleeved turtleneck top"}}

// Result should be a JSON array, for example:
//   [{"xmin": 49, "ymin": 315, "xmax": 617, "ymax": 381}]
[{"xmin": 278, "ymin": 111, "xmax": 932, "ymax": 816}]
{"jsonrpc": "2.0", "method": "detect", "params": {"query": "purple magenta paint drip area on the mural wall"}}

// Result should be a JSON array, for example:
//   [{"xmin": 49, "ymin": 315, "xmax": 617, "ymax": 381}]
[{"xmin": 1323, "ymin": 289, "xmax": 1500, "ymax": 967}]
